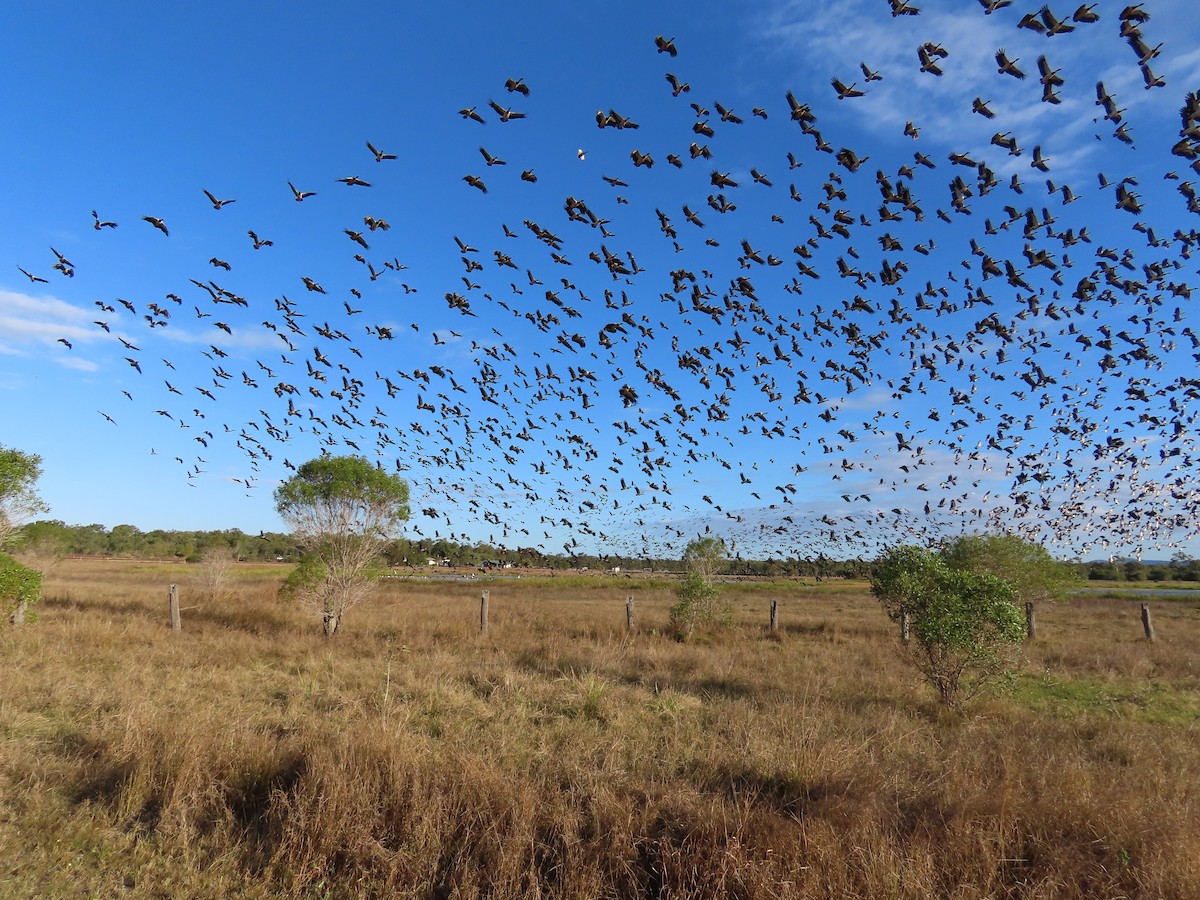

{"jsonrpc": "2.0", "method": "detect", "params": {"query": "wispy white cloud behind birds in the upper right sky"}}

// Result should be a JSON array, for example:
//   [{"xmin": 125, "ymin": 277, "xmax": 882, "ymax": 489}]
[{"xmin": 755, "ymin": 0, "xmax": 1200, "ymax": 179}]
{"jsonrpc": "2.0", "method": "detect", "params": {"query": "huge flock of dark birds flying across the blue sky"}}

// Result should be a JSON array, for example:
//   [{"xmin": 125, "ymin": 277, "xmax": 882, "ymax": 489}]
[{"xmin": 11, "ymin": 0, "xmax": 1200, "ymax": 557}]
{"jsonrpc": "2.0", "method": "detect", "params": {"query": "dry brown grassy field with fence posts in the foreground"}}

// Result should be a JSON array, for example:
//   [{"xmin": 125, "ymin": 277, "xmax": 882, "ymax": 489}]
[{"xmin": 0, "ymin": 560, "xmax": 1200, "ymax": 898}]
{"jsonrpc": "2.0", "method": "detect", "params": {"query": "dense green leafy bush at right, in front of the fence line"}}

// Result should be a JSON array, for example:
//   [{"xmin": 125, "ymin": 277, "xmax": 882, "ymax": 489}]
[{"xmin": 871, "ymin": 546, "xmax": 1025, "ymax": 707}]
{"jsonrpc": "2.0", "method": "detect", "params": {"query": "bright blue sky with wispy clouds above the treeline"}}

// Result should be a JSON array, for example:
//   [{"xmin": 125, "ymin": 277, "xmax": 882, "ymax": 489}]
[{"xmin": 0, "ymin": 0, "xmax": 1200, "ymax": 557}]
